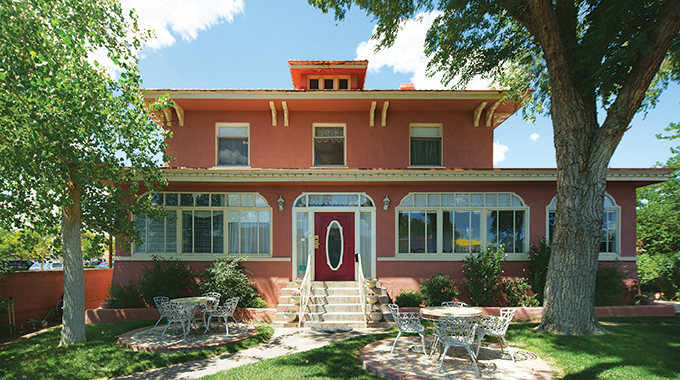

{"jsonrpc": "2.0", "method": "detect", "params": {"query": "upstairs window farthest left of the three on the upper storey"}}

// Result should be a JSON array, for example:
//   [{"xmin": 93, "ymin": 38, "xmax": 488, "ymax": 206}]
[{"xmin": 217, "ymin": 123, "xmax": 250, "ymax": 166}]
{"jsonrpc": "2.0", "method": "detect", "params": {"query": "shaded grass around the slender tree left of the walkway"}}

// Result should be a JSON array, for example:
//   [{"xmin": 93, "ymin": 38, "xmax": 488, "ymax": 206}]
[{"xmin": 0, "ymin": 321, "xmax": 274, "ymax": 380}]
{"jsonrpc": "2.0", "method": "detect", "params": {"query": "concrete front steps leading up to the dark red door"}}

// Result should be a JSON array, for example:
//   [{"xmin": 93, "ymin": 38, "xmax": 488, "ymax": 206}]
[{"xmin": 273, "ymin": 281, "xmax": 394, "ymax": 328}]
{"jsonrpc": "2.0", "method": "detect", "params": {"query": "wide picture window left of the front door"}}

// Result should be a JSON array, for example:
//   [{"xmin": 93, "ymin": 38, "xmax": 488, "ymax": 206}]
[{"xmin": 134, "ymin": 193, "xmax": 271, "ymax": 254}]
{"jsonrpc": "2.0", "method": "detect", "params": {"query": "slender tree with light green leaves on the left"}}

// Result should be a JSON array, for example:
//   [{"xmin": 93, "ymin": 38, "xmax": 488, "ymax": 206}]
[{"xmin": 0, "ymin": 0, "xmax": 167, "ymax": 345}]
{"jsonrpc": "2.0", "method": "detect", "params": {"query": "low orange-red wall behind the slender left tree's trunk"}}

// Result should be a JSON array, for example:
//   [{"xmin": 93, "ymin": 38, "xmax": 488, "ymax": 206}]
[{"xmin": 0, "ymin": 269, "xmax": 113, "ymax": 327}]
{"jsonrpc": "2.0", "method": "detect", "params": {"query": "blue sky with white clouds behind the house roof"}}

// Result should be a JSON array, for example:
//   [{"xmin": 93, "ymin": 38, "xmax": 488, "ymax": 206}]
[{"xmin": 122, "ymin": 0, "xmax": 680, "ymax": 168}]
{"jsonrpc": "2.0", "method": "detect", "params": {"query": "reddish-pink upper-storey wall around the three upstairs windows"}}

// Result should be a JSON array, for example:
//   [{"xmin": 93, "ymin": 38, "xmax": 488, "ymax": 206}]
[{"xmin": 167, "ymin": 111, "xmax": 493, "ymax": 169}]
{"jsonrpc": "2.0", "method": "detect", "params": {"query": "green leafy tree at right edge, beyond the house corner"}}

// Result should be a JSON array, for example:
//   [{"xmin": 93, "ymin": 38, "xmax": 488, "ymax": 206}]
[{"xmin": 637, "ymin": 123, "xmax": 680, "ymax": 298}]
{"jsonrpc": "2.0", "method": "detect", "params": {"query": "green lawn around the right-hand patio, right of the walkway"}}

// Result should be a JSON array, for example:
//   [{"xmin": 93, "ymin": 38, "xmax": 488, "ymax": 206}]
[{"xmin": 202, "ymin": 317, "xmax": 680, "ymax": 380}]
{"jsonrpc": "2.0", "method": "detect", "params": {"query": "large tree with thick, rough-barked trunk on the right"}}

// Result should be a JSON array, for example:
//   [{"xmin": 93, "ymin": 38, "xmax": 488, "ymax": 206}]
[{"xmin": 309, "ymin": 0, "xmax": 680, "ymax": 334}]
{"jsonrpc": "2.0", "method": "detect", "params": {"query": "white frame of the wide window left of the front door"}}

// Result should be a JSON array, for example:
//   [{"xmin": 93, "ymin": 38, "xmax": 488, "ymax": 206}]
[{"xmin": 131, "ymin": 191, "xmax": 274, "ymax": 261}]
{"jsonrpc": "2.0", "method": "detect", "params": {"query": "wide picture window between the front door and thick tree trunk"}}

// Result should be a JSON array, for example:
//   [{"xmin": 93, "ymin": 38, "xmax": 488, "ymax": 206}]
[{"xmin": 397, "ymin": 193, "xmax": 529, "ymax": 255}]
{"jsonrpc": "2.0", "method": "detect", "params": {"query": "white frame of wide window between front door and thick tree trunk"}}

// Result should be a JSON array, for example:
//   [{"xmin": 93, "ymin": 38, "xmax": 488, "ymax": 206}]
[{"xmin": 394, "ymin": 192, "xmax": 531, "ymax": 261}]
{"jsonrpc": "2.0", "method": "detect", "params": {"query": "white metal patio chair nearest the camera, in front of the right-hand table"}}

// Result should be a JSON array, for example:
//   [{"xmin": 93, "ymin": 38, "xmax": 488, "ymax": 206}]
[{"xmin": 432, "ymin": 317, "xmax": 480, "ymax": 377}]
